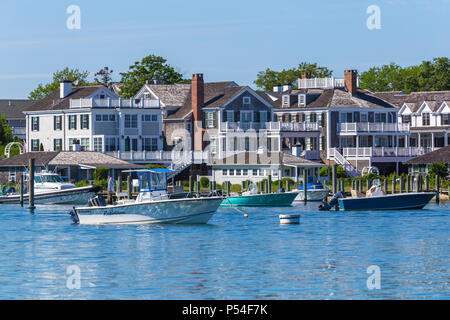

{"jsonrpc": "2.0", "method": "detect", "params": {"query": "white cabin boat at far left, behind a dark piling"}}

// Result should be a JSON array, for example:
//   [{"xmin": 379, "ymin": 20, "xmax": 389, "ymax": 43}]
[{"xmin": 0, "ymin": 172, "xmax": 100, "ymax": 204}]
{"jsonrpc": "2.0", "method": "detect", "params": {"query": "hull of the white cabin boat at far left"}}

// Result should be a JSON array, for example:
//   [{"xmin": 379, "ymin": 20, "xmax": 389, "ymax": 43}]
[{"xmin": 0, "ymin": 186, "xmax": 98, "ymax": 204}]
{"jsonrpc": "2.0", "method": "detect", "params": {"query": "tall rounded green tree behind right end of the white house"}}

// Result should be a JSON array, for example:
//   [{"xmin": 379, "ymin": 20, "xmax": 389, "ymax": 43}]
[{"xmin": 120, "ymin": 55, "xmax": 186, "ymax": 98}]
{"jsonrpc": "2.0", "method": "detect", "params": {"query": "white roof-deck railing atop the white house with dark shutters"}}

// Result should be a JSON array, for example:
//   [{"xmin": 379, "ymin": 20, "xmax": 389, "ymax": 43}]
[{"xmin": 70, "ymin": 98, "xmax": 160, "ymax": 108}]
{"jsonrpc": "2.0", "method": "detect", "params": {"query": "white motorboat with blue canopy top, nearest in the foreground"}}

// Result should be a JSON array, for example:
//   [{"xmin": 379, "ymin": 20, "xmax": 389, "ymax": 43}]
[{"xmin": 70, "ymin": 169, "xmax": 223, "ymax": 224}]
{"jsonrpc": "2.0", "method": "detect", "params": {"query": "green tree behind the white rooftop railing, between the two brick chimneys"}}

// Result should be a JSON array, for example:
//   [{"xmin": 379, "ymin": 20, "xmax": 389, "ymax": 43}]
[{"xmin": 254, "ymin": 62, "xmax": 333, "ymax": 91}]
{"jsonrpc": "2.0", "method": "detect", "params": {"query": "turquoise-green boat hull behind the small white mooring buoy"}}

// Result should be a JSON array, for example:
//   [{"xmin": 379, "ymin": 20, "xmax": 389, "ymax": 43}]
[{"xmin": 221, "ymin": 192, "xmax": 298, "ymax": 207}]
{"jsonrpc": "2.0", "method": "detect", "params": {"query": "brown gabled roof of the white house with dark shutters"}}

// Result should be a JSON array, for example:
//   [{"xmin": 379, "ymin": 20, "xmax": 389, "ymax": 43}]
[{"xmin": 25, "ymin": 85, "xmax": 107, "ymax": 111}]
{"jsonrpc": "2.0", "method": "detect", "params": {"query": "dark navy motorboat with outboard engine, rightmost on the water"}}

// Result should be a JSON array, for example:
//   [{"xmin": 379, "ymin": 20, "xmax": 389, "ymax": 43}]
[{"xmin": 319, "ymin": 179, "xmax": 436, "ymax": 211}]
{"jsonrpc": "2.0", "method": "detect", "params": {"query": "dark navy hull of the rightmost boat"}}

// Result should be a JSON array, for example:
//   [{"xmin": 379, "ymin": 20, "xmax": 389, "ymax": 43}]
[{"xmin": 338, "ymin": 192, "xmax": 435, "ymax": 211}]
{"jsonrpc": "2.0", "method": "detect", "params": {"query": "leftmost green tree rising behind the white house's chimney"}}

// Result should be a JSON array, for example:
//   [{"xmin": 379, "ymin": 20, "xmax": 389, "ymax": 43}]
[{"xmin": 28, "ymin": 67, "xmax": 89, "ymax": 100}]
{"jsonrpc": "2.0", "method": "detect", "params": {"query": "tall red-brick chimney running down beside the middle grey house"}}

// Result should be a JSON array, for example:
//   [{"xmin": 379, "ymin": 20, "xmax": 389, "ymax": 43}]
[{"xmin": 191, "ymin": 73, "xmax": 205, "ymax": 151}]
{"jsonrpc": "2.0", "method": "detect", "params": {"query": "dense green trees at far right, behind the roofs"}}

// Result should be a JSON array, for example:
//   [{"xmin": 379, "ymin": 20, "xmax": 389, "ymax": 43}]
[{"xmin": 360, "ymin": 57, "xmax": 450, "ymax": 93}]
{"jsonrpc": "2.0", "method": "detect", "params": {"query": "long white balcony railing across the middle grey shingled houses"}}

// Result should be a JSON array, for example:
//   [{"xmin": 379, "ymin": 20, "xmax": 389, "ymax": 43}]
[{"xmin": 220, "ymin": 122, "xmax": 319, "ymax": 132}]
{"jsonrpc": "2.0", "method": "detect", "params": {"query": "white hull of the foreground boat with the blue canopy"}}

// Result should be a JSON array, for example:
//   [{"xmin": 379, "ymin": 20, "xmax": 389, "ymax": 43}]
[{"xmin": 71, "ymin": 197, "xmax": 223, "ymax": 224}]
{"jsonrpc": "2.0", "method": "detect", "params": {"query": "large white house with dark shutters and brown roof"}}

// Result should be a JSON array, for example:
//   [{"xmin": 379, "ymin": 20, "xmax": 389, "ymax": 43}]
[{"xmin": 24, "ymin": 82, "xmax": 163, "ymax": 152}]
